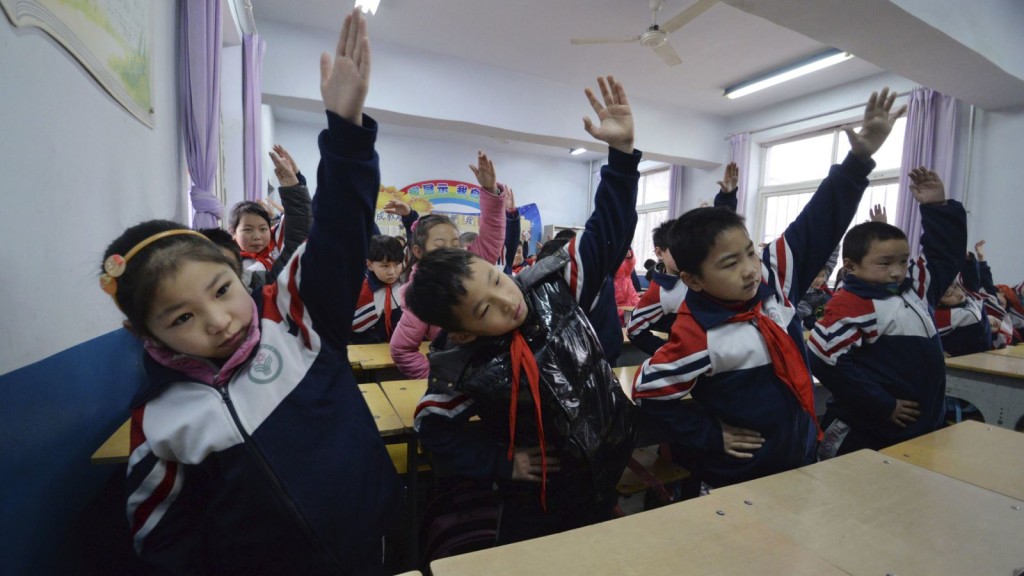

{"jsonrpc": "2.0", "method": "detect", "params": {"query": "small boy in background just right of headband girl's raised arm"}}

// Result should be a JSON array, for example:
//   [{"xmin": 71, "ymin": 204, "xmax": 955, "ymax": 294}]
[{"xmin": 351, "ymin": 235, "xmax": 406, "ymax": 344}]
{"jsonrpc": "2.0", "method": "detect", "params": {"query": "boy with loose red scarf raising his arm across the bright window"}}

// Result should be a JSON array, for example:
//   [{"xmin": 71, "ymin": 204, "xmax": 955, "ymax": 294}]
[{"xmin": 633, "ymin": 88, "xmax": 905, "ymax": 487}]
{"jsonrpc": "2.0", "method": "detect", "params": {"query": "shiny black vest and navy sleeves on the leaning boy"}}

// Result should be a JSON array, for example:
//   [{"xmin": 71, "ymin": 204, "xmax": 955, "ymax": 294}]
[{"xmin": 414, "ymin": 150, "xmax": 640, "ymax": 510}]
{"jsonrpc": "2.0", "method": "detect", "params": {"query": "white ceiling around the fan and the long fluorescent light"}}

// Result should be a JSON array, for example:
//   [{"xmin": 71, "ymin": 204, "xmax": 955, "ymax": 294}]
[{"xmin": 252, "ymin": 0, "xmax": 883, "ymax": 117}]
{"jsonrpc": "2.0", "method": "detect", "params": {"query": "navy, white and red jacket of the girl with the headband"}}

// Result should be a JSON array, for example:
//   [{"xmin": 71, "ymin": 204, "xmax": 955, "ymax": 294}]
[{"xmin": 121, "ymin": 113, "xmax": 401, "ymax": 575}]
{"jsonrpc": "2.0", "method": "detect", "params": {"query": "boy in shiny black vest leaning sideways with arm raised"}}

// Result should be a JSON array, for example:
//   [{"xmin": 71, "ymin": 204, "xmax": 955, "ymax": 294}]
[{"xmin": 406, "ymin": 76, "xmax": 640, "ymax": 543}]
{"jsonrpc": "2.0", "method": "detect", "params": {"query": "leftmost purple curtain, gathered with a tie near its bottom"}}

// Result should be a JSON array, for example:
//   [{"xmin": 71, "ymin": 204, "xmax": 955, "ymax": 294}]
[{"xmin": 178, "ymin": 0, "xmax": 224, "ymax": 229}]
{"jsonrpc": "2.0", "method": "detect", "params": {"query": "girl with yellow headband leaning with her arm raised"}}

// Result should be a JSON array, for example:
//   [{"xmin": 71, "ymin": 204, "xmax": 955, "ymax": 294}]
[{"xmin": 100, "ymin": 10, "xmax": 401, "ymax": 575}]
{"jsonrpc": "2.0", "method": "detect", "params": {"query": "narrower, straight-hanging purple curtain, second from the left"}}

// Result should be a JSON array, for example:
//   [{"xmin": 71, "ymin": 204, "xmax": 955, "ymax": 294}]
[{"xmin": 242, "ymin": 33, "xmax": 266, "ymax": 202}]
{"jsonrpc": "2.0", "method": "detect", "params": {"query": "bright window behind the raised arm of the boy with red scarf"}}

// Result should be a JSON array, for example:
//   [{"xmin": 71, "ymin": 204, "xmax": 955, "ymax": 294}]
[{"xmin": 757, "ymin": 118, "xmax": 906, "ymax": 250}]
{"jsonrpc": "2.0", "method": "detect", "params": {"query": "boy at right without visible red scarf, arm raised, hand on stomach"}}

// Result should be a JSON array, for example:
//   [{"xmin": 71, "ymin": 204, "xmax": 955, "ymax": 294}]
[{"xmin": 809, "ymin": 167, "xmax": 967, "ymax": 458}]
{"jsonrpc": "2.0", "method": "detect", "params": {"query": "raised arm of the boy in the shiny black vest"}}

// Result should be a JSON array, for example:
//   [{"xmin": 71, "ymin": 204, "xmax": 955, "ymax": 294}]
[{"xmin": 563, "ymin": 76, "xmax": 640, "ymax": 310}]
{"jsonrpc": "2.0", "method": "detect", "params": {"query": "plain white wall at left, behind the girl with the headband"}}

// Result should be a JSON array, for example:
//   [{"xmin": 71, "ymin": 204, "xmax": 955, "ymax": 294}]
[{"xmin": 0, "ymin": 2, "xmax": 187, "ymax": 373}]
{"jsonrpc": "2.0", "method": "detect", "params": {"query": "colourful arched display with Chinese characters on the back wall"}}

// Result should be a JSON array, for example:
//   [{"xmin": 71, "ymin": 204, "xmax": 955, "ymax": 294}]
[{"xmin": 375, "ymin": 179, "xmax": 480, "ymax": 236}]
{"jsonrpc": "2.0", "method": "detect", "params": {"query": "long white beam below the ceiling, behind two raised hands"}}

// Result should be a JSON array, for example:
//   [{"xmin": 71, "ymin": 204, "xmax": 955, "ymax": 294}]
[{"xmin": 259, "ymin": 20, "xmax": 723, "ymax": 167}]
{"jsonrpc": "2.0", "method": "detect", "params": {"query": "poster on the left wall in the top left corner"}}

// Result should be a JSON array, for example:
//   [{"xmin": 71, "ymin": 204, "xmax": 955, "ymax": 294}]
[{"xmin": 0, "ymin": 0, "xmax": 154, "ymax": 128}]
